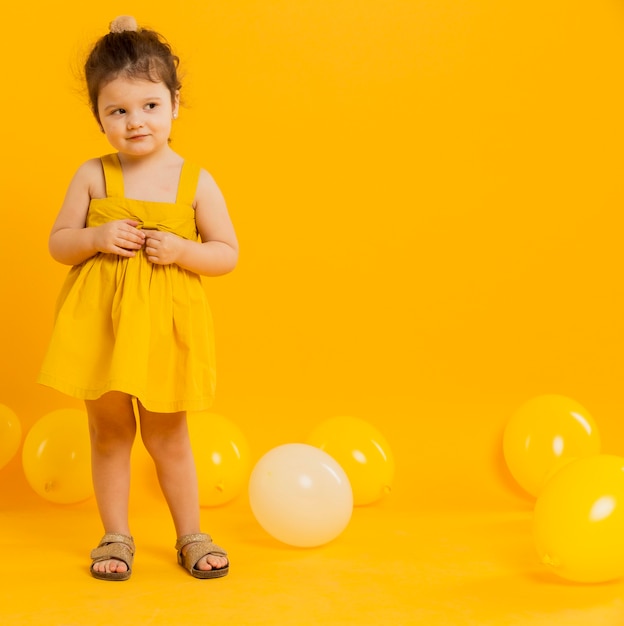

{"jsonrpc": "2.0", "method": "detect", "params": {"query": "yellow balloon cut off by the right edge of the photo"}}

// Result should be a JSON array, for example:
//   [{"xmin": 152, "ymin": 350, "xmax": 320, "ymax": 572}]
[{"xmin": 533, "ymin": 454, "xmax": 624, "ymax": 583}]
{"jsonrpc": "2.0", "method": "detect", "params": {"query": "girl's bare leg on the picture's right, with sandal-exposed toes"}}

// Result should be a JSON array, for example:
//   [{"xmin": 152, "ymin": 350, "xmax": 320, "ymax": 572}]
[{"xmin": 139, "ymin": 403, "xmax": 227, "ymax": 570}]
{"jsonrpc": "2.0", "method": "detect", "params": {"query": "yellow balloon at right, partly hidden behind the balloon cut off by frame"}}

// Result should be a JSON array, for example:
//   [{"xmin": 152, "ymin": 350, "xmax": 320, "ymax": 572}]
[{"xmin": 503, "ymin": 395, "xmax": 601, "ymax": 496}]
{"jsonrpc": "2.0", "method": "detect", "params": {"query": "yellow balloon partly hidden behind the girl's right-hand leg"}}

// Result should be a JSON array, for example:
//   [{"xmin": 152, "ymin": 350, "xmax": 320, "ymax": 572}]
[{"xmin": 187, "ymin": 412, "xmax": 250, "ymax": 506}]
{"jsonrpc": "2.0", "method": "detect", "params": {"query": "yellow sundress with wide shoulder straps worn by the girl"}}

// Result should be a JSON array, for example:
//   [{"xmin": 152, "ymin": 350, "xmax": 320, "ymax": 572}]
[{"xmin": 38, "ymin": 154, "xmax": 216, "ymax": 413}]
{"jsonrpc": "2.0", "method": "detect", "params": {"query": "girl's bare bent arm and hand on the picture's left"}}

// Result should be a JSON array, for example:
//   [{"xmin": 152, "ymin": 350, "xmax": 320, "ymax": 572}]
[{"xmin": 48, "ymin": 159, "xmax": 145, "ymax": 265}]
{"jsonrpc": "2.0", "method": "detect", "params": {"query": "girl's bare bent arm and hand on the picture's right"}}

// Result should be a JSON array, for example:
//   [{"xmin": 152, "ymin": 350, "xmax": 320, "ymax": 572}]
[{"xmin": 145, "ymin": 170, "xmax": 238, "ymax": 276}]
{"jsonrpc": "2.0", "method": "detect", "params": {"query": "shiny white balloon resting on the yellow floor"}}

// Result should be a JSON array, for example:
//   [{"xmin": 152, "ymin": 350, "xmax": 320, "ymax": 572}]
[{"xmin": 249, "ymin": 443, "xmax": 353, "ymax": 548}]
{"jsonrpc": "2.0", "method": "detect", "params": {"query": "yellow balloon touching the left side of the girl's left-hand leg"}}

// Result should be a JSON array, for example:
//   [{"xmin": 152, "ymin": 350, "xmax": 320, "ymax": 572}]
[{"xmin": 22, "ymin": 409, "xmax": 93, "ymax": 504}]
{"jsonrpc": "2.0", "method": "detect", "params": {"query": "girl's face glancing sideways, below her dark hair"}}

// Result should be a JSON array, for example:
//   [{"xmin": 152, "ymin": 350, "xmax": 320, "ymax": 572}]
[{"xmin": 98, "ymin": 77, "xmax": 179, "ymax": 157}]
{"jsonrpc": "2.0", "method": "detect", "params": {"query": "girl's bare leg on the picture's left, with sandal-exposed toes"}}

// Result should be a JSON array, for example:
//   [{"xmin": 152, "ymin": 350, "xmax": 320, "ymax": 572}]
[{"xmin": 85, "ymin": 391, "xmax": 136, "ymax": 572}]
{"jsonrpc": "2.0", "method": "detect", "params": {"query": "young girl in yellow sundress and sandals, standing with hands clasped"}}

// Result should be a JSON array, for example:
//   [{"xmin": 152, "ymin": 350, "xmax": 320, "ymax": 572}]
[{"xmin": 39, "ymin": 17, "xmax": 238, "ymax": 580}]
